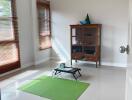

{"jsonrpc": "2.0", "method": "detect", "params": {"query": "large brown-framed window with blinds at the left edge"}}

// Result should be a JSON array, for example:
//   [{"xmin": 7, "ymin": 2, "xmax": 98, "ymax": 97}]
[{"xmin": 0, "ymin": 0, "xmax": 20, "ymax": 74}]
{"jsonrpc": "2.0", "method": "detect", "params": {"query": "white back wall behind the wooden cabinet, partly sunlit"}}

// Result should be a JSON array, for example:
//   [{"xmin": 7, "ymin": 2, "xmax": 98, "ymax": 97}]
[{"xmin": 51, "ymin": 0, "xmax": 128, "ymax": 67}]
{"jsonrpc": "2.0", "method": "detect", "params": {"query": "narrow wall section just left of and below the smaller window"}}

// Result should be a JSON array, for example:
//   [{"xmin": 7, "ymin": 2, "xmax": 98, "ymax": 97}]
[{"xmin": 30, "ymin": 0, "xmax": 51, "ymax": 64}]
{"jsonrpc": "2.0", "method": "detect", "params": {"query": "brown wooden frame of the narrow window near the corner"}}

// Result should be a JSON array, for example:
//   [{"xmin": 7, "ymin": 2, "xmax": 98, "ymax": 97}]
[{"xmin": 37, "ymin": 0, "xmax": 52, "ymax": 51}]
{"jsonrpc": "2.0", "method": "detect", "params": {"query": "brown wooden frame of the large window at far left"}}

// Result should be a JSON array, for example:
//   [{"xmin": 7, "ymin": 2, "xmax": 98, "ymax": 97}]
[{"xmin": 0, "ymin": 0, "xmax": 21, "ymax": 74}]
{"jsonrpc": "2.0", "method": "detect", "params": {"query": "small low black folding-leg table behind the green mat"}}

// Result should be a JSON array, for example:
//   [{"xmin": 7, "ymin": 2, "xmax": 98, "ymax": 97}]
[{"xmin": 54, "ymin": 66, "xmax": 81, "ymax": 80}]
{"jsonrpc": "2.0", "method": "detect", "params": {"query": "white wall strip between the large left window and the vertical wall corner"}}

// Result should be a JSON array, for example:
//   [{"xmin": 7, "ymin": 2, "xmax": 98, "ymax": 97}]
[{"xmin": 16, "ymin": 0, "xmax": 34, "ymax": 67}]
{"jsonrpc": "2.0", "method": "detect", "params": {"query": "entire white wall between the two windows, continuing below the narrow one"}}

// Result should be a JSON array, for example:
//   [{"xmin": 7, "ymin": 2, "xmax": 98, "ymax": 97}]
[{"xmin": 16, "ymin": 0, "xmax": 50, "ymax": 68}]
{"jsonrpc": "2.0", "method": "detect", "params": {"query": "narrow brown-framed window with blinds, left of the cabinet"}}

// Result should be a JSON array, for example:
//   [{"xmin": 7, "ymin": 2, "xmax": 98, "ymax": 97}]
[{"xmin": 37, "ymin": 0, "xmax": 51, "ymax": 50}]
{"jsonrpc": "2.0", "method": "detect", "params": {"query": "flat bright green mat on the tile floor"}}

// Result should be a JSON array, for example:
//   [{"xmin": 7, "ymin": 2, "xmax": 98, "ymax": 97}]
[{"xmin": 19, "ymin": 76, "xmax": 89, "ymax": 100}]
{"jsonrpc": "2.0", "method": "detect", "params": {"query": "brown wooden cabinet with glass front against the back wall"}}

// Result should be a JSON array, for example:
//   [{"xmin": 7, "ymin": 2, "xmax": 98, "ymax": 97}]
[{"xmin": 70, "ymin": 24, "xmax": 101, "ymax": 67}]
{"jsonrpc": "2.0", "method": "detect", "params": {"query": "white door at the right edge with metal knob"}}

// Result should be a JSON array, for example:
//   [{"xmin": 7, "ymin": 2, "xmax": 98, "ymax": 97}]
[{"xmin": 126, "ymin": 0, "xmax": 132, "ymax": 100}]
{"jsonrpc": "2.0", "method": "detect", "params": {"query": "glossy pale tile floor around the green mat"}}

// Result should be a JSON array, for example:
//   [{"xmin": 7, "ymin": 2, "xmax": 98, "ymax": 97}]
[{"xmin": 0, "ymin": 61, "xmax": 126, "ymax": 100}]
